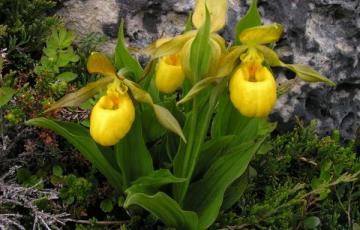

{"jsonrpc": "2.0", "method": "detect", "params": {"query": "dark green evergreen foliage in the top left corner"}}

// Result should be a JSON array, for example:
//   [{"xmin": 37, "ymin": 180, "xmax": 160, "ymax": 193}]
[{"xmin": 0, "ymin": 0, "xmax": 61, "ymax": 70}]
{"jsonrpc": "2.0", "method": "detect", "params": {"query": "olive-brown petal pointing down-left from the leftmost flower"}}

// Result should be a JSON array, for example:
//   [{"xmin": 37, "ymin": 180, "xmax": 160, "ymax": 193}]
[{"xmin": 45, "ymin": 77, "xmax": 114, "ymax": 112}]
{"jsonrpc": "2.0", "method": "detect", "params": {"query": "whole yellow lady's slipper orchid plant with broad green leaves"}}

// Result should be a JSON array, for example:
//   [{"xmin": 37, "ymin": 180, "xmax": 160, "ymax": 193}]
[{"xmin": 28, "ymin": 0, "xmax": 334, "ymax": 230}]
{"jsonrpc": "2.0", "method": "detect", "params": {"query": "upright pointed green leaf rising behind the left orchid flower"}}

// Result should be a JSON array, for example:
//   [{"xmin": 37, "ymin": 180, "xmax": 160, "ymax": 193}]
[{"xmin": 115, "ymin": 19, "xmax": 144, "ymax": 81}]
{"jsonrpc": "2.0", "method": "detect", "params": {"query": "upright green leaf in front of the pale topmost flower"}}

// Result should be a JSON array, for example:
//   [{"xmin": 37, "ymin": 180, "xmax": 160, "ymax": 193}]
[{"xmin": 189, "ymin": 6, "xmax": 211, "ymax": 82}]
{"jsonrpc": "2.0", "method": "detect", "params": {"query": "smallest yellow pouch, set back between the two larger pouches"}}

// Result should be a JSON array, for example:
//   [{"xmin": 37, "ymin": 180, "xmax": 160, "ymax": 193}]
[{"xmin": 155, "ymin": 55, "xmax": 185, "ymax": 93}]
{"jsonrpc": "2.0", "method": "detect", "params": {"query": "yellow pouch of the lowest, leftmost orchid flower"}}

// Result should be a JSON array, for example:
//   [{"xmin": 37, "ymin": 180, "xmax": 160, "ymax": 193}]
[{"xmin": 90, "ymin": 93, "xmax": 135, "ymax": 146}]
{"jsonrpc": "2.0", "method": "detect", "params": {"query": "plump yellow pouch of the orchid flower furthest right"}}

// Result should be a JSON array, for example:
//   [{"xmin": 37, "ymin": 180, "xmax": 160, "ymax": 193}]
[{"xmin": 229, "ymin": 66, "xmax": 276, "ymax": 117}]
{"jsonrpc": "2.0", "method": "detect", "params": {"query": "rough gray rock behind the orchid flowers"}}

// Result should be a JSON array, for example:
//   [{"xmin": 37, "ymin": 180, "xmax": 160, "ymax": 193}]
[{"xmin": 58, "ymin": 0, "xmax": 360, "ymax": 139}]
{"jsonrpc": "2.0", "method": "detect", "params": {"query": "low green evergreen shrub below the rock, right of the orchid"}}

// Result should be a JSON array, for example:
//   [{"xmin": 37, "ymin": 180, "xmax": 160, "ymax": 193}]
[{"xmin": 216, "ymin": 122, "xmax": 360, "ymax": 229}]
